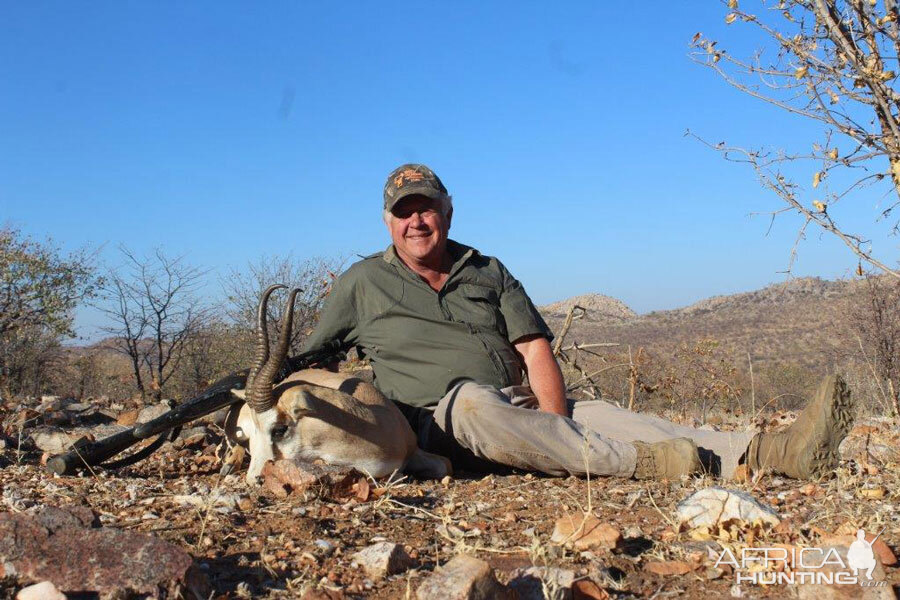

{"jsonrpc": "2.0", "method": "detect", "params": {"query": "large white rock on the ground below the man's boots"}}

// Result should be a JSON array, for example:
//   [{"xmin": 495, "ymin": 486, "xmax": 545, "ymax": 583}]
[{"xmin": 676, "ymin": 487, "xmax": 781, "ymax": 528}]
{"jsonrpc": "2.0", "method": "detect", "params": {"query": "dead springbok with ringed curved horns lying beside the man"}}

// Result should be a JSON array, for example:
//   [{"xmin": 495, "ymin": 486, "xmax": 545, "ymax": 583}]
[{"xmin": 225, "ymin": 284, "xmax": 452, "ymax": 484}]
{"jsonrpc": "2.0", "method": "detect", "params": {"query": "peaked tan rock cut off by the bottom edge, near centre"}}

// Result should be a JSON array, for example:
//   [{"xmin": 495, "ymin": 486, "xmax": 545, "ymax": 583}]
[{"xmin": 416, "ymin": 554, "xmax": 511, "ymax": 600}]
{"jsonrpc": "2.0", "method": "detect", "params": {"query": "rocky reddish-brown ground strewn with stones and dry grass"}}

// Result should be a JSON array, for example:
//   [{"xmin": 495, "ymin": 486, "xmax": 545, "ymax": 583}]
[{"xmin": 0, "ymin": 398, "xmax": 900, "ymax": 599}]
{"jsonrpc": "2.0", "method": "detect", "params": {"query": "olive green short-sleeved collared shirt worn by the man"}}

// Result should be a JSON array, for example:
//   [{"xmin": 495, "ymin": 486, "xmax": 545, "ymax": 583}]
[{"xmin": 305, "ymin": 240, "xmax": 553, "ymax": 406}]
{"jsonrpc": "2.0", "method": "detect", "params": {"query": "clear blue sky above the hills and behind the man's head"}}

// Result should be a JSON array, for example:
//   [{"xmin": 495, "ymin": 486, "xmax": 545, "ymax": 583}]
[{"xmin": 0, "ymin": 1, "xmax": 884, "ymax": 338}]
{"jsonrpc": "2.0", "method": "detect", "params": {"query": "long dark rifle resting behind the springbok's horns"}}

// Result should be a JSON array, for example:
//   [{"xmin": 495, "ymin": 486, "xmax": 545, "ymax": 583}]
[{"xmin": 47, "ymin": 340, "xmax": 344, "ymax": 475}]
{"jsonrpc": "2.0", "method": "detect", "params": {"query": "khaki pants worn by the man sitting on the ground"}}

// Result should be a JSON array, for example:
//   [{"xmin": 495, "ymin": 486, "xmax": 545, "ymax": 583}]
[{"xmin": 400, "ymin": 381, "xmax": 755, "ymax": 478}]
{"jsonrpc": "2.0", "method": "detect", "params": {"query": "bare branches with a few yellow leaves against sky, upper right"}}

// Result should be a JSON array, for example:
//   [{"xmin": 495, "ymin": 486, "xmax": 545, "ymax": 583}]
[{"xmin": 691, "ymin": 0, "xmax": 900, "ymax": 278}]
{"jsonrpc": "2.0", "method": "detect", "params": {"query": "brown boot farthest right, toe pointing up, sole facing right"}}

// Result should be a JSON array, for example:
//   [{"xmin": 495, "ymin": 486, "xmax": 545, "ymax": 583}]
[{"xmin": 747, "ymin": 375, "xmax": 853, "ymax": 479}]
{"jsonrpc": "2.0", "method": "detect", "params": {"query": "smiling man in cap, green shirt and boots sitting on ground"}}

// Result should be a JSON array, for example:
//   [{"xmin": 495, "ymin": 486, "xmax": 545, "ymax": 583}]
[{"xmin": 306, "ymin": 164, "xmax": 852, "ymax": 479}]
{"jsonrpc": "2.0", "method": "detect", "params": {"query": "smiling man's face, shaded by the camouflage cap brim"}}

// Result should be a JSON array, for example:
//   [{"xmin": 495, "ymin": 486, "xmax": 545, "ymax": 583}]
[{"xmin": 388, "ymin": 196, "xmax": 453, "ymax": 263}]
